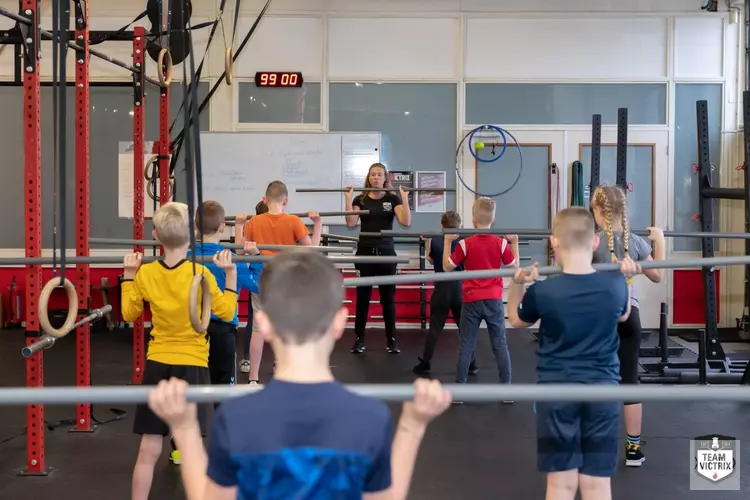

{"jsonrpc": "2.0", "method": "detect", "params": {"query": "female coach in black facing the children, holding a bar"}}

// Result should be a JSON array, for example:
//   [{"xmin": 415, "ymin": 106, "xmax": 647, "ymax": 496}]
[{"xmin": 345, "ymin": 163, "xmax": 411, "ymax": 354}]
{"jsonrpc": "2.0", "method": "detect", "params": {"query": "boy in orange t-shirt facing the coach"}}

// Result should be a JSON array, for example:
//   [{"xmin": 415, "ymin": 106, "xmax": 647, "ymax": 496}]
[{"xmin": 234, "ymin": 181, "xmax": 323, "ymax": 384}]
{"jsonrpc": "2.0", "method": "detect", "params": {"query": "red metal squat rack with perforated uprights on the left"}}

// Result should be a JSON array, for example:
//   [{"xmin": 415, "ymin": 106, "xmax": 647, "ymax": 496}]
[{"xmin": 19, "ymin": 4, "xmax": 171, "ymax": 475}]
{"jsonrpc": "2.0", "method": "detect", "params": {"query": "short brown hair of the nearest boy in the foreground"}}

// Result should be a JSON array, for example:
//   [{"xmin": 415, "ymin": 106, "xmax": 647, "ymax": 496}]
[{"xmin": 260, "ymin": 250, "xmax": 344, "ymax": 345}]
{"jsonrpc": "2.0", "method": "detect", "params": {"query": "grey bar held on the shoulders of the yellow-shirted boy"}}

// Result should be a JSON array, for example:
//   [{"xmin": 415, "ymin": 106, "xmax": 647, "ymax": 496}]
[{"xmin": 0, "ymin": 255, "xmax": 409, "ymax": 266}]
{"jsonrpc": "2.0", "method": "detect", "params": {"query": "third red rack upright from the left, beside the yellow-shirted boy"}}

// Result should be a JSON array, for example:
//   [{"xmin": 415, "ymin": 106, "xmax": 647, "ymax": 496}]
[{"xmin": 132, "ymin": 26, "xmax": 146, "ymax": 384}]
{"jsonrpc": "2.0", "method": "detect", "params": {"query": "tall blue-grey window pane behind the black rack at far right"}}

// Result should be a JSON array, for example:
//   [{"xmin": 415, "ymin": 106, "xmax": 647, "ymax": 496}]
[{"xmin": 673, "ymin": 83, "xmax": 723, "ymax": 252}]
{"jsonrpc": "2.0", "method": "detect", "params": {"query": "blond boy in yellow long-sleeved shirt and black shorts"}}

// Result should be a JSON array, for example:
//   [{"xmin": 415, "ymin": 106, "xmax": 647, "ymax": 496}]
[{"xmin": 122, "ymin": 202, "xmax": 237, "ymax": 500}]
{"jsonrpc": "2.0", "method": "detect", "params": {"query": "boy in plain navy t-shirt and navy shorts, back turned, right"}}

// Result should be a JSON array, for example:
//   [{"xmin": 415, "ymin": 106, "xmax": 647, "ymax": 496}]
[{"xmin": 508, "ymin": 207, "xmax": 640, "ymax": 500}]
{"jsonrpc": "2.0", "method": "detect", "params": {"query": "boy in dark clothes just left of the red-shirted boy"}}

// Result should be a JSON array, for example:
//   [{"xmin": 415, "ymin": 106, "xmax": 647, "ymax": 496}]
[{"xmin": 413, "ymin": 210, "xmax": 479, "ymax": 375}]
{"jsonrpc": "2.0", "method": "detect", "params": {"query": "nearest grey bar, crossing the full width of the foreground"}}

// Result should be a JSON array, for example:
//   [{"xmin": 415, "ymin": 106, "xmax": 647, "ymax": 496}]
[{"xmin": 0, "ymin": 384, "xmax": 750, "ymax": 406}]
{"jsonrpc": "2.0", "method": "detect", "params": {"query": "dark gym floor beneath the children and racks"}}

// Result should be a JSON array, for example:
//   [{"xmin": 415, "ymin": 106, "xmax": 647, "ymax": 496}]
[{"xmin": 0, "ymin": 330, "xmax": 750, "ymax": 500}]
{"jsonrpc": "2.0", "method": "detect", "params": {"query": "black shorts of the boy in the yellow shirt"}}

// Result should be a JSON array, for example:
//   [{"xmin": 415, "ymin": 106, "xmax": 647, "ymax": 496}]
[{"xmin": 133, "ymin": 361, "xmax": 211, "ymax": 436}]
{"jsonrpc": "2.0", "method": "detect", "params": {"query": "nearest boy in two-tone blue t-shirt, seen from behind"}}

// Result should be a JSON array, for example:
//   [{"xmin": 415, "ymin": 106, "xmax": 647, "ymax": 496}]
[{"xmin": 149, "ymin": 251, "xmax": 451, "ymax": 500}]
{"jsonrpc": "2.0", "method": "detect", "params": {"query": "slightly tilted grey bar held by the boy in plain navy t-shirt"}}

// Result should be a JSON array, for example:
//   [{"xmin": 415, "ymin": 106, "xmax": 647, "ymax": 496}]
[{"xmin": 344, "ymin": 255, "xmax": 750, "ymax": 287}]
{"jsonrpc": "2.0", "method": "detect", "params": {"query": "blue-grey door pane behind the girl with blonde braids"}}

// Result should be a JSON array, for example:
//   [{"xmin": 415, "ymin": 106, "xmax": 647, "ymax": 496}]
[{"xmin": 581, "ymin": 145, "xmax": 654, "ymax": 230}]
